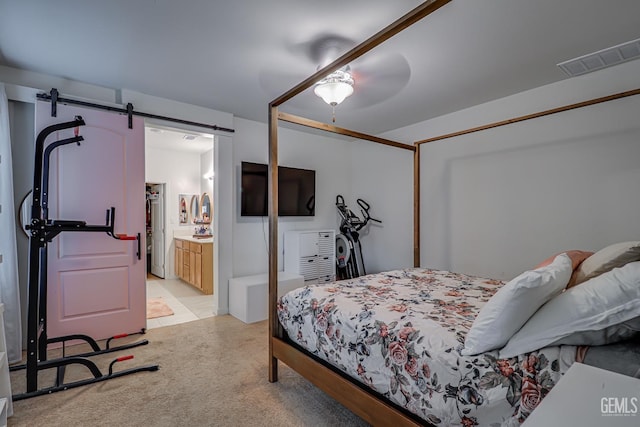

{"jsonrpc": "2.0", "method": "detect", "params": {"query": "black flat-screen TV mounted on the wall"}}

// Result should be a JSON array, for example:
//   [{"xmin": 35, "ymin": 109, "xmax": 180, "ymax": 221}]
[{"xmin": 240, "ymin": 162, "xmax": 316, "ymax": 216}]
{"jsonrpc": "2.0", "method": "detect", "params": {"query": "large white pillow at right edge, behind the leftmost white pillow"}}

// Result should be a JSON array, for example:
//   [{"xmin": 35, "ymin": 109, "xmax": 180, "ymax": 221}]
[{"xmin": 500, "ymin": 262, "xmax": 640, "ymax": 358}]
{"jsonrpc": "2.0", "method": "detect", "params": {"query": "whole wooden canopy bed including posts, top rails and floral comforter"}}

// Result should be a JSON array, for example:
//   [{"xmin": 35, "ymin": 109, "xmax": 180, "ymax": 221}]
[{"xmin": 269, "ymin": 0, "xmax": 640, "ymax": 426}]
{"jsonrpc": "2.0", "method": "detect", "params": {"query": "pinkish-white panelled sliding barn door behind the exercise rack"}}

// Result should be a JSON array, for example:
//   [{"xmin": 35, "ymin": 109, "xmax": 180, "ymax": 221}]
[{"xmin": 36, "ymin": 101, "xmax": 146, "ymax": 339}]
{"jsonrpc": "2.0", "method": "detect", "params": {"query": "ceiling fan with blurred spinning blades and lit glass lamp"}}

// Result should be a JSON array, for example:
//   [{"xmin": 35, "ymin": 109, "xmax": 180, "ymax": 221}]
[{"xmin": 259, "ymin": 34, "xmax": 411, "ymax": 121}]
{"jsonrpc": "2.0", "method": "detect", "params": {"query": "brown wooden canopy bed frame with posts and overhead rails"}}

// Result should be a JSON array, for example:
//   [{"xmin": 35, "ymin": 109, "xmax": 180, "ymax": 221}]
[{"xmin": 269, "ymin": 0, "xmax": 640, "ymax": 426}]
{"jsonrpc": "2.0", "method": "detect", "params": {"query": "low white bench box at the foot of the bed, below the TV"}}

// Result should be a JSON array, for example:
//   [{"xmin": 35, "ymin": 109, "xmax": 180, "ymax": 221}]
[{"xmin": 229, "ymin": 271, "xmax": 304, "ymax": 323}]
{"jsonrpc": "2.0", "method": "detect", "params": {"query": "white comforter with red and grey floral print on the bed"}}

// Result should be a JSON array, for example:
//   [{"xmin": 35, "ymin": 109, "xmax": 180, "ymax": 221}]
[{"xmin": 278, "ymin": 268, "xmax": 576, "ymax": 426}]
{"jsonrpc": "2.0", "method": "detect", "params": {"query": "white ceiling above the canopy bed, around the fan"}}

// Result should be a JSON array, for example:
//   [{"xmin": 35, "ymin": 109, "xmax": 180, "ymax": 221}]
[{"xmin": 0, "ymin": 0, "xmax": 640, "ymax": 134}]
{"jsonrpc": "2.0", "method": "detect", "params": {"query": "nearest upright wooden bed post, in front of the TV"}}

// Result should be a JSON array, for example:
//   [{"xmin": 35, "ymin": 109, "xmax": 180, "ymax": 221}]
[{"xmin": 269, "ymin": 104, "xmax": 279, "ymax": 382}]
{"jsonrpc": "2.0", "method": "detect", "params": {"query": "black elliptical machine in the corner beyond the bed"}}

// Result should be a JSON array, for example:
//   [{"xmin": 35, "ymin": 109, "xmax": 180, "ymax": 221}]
[{"xmin": 336, "ymin": 195, "xmax": 382, "ymax": 280}]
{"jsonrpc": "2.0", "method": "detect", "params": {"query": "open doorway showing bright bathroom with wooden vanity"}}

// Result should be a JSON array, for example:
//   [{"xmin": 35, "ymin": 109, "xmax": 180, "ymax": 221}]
[{"xmin": 145, "ymin": 123, "xmax": 216, "ymax": 329}]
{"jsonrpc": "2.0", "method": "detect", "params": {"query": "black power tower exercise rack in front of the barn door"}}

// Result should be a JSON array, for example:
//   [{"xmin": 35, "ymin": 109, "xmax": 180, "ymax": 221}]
[{"xmin": 10, "ymin": 116, "xmax": 159, "ymax": 400}]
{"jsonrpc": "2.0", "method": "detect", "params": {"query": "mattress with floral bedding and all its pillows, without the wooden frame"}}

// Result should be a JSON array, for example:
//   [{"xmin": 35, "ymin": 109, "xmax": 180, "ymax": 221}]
[{"xmin": 277, "ymin": 251, "xmax": 640, "ymax": 426}]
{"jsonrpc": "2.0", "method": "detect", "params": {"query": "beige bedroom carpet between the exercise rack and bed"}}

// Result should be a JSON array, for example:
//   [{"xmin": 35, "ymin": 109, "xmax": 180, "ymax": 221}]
[{"xmin": 8, "ymin": 316, "xmax": 366, "ymax": 427}]
